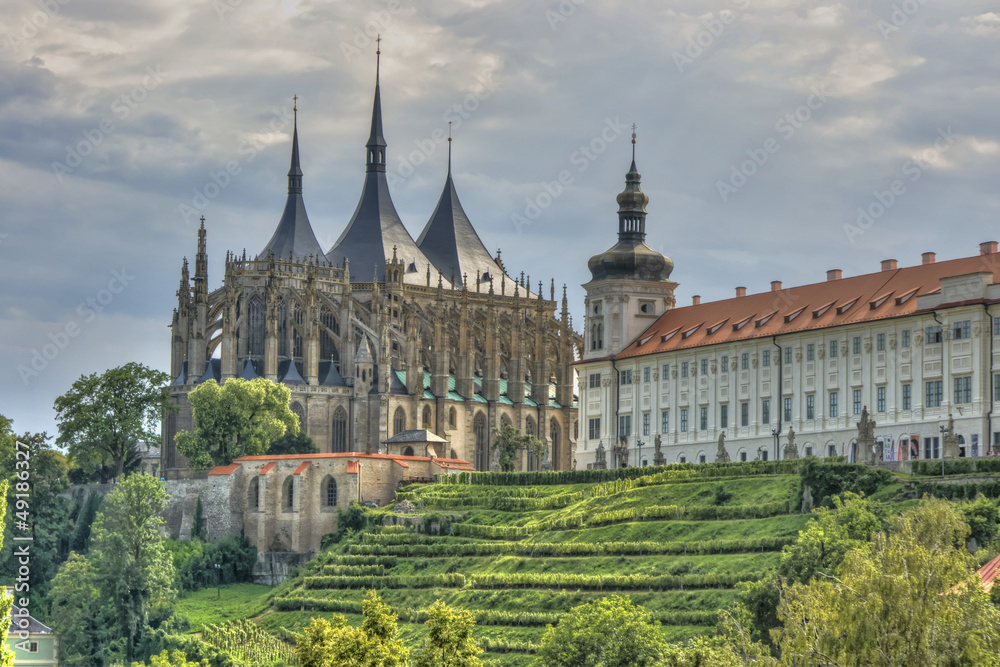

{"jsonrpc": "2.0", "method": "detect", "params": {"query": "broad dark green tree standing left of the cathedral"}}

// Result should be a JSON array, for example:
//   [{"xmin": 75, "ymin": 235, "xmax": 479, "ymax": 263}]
[{"xmin": 55, "ymin": 362, "xmax": 177, "ymax": 477}]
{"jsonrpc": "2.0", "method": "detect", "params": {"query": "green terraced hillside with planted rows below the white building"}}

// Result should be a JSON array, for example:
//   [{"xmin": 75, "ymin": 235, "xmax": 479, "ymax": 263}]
[{"xmin": 260, "ymin": 461, "xmax": 808, "ymax": 665}]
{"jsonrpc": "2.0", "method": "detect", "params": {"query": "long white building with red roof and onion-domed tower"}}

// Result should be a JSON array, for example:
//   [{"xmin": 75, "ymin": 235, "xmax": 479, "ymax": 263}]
[{"xmin": 576, "ymin": 135, "xmax": 1000, "ymax": 468}]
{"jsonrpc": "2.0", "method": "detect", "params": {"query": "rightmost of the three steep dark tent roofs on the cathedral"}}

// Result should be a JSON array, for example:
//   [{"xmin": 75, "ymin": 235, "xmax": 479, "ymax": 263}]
[{"xmin": 417, "ymin": 144, "xmax": 523, "ymax": 294}]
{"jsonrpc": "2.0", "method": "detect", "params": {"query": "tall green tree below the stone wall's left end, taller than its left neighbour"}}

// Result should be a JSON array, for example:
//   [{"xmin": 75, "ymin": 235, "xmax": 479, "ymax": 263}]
[{"xmin": 91, "ymin": 473, "xmax": 176, "ymax": 660}]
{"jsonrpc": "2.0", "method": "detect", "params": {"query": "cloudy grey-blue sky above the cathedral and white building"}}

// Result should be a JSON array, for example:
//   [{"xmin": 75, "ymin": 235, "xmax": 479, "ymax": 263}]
[{"xmin": 0, "ymin": 0, "xmax": 1000, "ymax": 434}]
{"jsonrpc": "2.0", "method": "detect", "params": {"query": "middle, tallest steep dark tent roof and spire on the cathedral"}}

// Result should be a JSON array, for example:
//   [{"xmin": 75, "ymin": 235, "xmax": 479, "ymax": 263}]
[{"xmin": 326, "ymin": 45, "xmax": 442, "ymax": 286}]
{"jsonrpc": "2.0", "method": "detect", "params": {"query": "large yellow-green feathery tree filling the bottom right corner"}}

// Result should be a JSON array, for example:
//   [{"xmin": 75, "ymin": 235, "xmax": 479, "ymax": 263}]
[{"xmin": 776, "ymin": 499, "xmax": 1000, "ymax": 667}]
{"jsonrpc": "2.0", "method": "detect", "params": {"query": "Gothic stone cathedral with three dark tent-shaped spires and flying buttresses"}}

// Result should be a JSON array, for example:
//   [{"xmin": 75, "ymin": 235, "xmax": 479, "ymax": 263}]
[{"xmin": 162, "ymin": 53, "xmax": 582, "ymax": 479}]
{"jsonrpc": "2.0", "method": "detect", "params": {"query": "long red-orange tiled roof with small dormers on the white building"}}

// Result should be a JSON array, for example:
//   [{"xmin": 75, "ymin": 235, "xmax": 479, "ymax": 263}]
[{"xmin": 576, "ymin": 252, "xmax": 1000, "ymax": 363}]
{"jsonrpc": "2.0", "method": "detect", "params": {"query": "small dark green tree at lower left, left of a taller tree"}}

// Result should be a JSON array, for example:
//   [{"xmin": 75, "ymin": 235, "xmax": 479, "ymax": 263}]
[{"xmin": 50, "ymin": 553, "xmax": 111, "ymax": 667}]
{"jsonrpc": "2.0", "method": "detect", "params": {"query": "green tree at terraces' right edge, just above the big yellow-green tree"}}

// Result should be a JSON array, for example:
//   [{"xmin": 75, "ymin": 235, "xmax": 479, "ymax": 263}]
[{"xmin": 779, "ymin": 492, "xmax": 885, "ymax": 583}]
